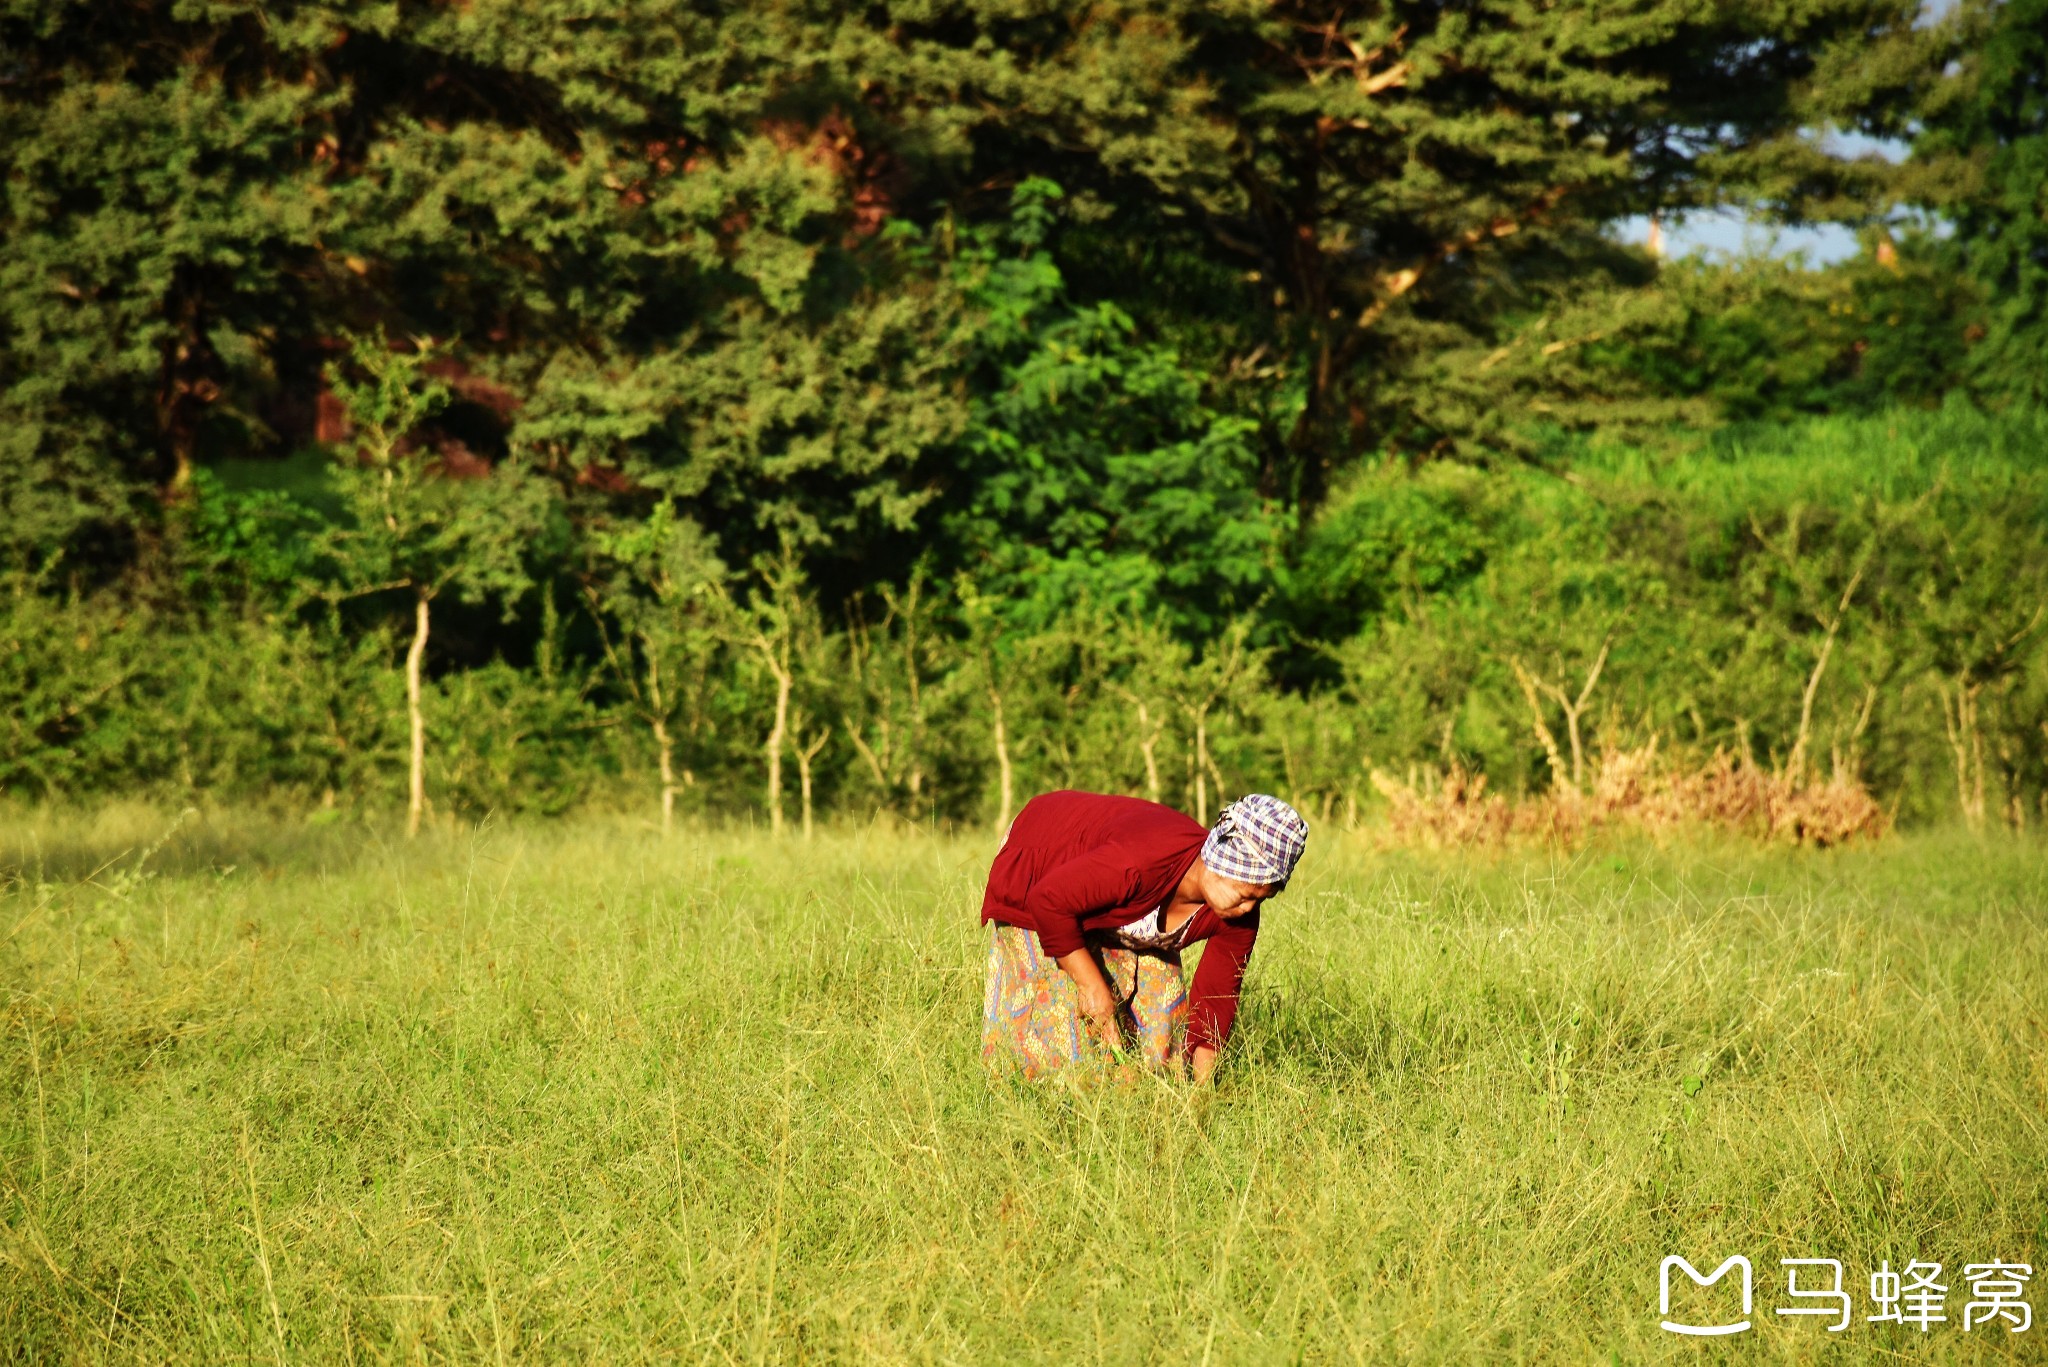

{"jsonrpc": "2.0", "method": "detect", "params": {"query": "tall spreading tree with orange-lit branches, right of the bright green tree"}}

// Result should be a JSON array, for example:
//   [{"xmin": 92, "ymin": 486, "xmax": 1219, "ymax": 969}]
[{"xmin": 913, "ymin": 0, "xmax": 1950, "ymax": 498}]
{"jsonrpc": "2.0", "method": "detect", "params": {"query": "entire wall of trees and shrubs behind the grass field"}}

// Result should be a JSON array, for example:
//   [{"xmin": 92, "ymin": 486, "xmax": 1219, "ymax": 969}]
[{"xmin": 12, "ymin": 0, "xmax": 2048, "ymax": 836}]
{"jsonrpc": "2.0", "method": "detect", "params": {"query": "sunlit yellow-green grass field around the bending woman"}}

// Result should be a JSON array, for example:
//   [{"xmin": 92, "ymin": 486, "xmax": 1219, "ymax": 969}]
[{"xmin": 0, "ymin": 812, "xmax": 2048, "ymax": 1363}]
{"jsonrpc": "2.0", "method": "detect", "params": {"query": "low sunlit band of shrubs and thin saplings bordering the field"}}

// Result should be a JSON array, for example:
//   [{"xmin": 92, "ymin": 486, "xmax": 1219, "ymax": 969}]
[{"xmin": 0, "ymin": 406, "xmax": 2048, "ymax": 828}]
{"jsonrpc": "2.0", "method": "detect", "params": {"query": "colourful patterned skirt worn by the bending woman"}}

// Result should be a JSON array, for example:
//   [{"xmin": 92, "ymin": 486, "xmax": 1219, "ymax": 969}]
[{"xmin": 981, "ymin": 922, "xmax": 1188, "ymax": 1078}]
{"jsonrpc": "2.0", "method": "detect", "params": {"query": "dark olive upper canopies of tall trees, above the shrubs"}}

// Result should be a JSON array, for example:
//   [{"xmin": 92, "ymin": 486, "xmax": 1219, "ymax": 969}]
[{"xmin": 0, "ymin": 0, "xmax": 1948, "ymax": 565}]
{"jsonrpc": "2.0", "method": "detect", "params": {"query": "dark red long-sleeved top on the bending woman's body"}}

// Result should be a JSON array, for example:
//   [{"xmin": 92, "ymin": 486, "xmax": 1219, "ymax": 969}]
[{"xmin": 981, "ymin": 791, "xmax": 1260, "ymax": 1049}]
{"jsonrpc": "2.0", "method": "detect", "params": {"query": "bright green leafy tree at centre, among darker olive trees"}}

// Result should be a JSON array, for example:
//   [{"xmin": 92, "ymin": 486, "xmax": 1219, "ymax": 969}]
[{"xmin": 942, "ymin": 180, "xmax": 1284, "ymax": 635}]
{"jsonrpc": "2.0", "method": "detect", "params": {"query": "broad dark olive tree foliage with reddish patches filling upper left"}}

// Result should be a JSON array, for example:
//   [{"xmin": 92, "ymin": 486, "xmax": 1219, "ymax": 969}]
[{"xmin": 0, "ymin": 0, "xmax": 963, "ymax": 577}]
